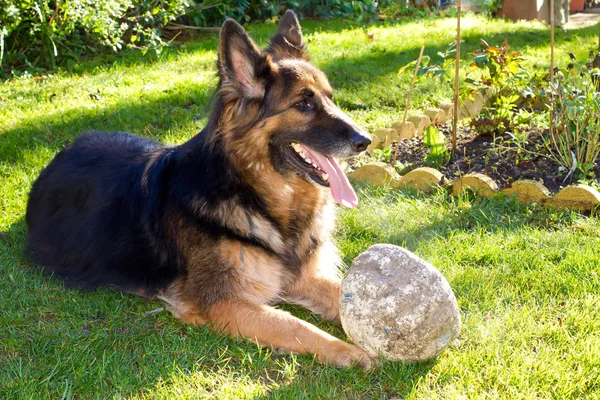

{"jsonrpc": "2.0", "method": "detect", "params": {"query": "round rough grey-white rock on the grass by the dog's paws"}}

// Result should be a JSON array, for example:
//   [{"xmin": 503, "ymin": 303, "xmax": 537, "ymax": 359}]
[{"xmin": 340, "ymin": 244, "xmax": 461, "ymax": 362}]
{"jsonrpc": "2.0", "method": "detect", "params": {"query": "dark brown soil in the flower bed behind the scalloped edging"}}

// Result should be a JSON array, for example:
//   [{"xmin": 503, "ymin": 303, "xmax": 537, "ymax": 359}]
[{"xmin": 380, "ymin": 126, "xmax": 600, "ymax": 193}]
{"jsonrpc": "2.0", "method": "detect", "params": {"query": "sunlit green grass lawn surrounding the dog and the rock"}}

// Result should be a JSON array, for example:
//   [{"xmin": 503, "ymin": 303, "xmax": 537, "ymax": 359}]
[{"xmin": 0, "ymin": 16, "xmax": 600, "ymax": 399}]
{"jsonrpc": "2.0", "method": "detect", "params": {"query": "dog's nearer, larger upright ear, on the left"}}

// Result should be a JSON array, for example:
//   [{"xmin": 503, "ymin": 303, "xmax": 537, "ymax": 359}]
[{"xmin": 219, "ymin": 19, "xmax": 273, "ymax": 100}]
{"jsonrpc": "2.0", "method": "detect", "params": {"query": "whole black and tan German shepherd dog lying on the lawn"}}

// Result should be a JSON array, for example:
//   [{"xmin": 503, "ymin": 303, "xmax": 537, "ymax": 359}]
[{"xmin": 26, "ymin": 11, "xmax": 376, "ymax": 368}]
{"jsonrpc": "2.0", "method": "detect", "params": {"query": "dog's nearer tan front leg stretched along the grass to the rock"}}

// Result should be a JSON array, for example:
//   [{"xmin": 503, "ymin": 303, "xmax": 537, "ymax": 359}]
[{"xmin": 209, "ymin": 301, "xmax": 376, "ymax": 369}]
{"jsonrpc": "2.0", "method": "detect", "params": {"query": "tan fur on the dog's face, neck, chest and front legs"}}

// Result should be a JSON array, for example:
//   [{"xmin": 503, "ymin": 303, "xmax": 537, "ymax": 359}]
[{"xmin": 159, "ymin": 14, "xmax": 376, "ymax": 368}]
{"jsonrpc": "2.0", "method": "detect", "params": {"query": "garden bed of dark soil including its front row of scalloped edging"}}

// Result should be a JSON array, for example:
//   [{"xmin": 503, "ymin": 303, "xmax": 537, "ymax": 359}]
[{"xmin": 349, "ymin": 124, "xmax": 600, "ymax": 211}]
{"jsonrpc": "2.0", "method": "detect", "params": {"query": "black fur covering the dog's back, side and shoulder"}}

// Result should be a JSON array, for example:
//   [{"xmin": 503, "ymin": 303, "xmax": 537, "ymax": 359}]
[{"xmin": 26, "ymin": 132, "xmax": 276, "ymax": 294}]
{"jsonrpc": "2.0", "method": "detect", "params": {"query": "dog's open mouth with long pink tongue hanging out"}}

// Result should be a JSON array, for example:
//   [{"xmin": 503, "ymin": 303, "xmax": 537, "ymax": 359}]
[{"xmin": 290, "ymin": 142, "xmax": 358, "ymax": 208}]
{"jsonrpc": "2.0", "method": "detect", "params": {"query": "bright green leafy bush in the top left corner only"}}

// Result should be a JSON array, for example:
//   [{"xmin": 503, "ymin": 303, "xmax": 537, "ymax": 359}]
[{"xmin": 0, "ymin": 0, "xmax": 189, "ymax": 72}]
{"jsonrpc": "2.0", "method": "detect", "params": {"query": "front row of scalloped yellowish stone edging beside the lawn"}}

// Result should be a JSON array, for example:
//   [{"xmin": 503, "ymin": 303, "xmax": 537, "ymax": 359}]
[{"xmin": 348, "ymin": 162, "xmax": 600, "ymax": 211}]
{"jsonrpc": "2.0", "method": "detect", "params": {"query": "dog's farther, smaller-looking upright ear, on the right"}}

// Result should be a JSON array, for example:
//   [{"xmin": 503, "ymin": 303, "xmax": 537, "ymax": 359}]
[{"xmin": 267, "ymin": 10, "xmax": 309, "ymax": 61}]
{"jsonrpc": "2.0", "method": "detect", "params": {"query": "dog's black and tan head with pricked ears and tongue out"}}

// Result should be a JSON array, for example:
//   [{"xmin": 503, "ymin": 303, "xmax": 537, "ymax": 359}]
[{"xmin": 217, "ymin": 11, "xmax": 371, "ymax": 207}]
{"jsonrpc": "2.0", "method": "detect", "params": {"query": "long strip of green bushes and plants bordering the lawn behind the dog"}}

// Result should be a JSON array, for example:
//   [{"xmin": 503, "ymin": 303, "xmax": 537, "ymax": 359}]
[{"xmin": 0, "ymin": 0, "xmax": 389, "ymax": 74}]
